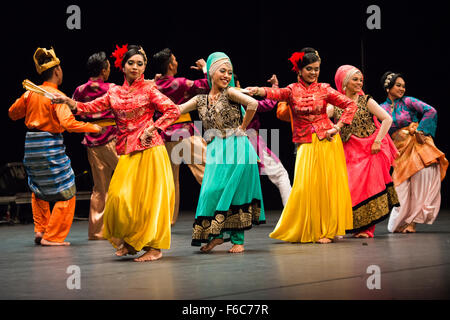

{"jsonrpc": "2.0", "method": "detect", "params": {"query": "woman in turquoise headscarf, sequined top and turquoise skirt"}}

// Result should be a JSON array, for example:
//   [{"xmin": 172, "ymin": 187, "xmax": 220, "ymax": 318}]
[{"xmin": 180, "ymin": 52, "xmax": 265, "ymax": 253}]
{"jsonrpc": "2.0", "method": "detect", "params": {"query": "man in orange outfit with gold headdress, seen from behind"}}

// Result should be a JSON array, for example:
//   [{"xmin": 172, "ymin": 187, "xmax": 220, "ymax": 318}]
[{"xmin": 9, "ymin": 48, "xmax": 102, "ymax": 246}]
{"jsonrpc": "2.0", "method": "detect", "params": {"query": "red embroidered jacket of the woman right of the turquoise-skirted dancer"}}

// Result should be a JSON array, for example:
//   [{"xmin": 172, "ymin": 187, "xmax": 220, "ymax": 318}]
[{"xmin": 264, "ymin": 81, "xmax": 358, "ymax": 143}]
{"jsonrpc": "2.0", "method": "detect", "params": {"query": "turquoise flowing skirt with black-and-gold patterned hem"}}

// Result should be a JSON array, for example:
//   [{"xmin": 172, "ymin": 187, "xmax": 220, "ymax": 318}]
[{"xmin": 192, "ymin": 136, "xmax": 265, "ymax": 246}]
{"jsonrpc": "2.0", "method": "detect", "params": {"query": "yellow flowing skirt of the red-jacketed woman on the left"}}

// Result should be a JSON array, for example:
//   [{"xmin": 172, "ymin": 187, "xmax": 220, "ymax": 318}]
[{"xmin": 103, "ymin": 146, "xmax": 175, "ymax": 251}]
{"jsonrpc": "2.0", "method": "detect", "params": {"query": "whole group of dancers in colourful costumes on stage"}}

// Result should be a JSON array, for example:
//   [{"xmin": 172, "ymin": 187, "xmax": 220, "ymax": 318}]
[{"xmin": 9, "ymin": 45, "xmax": 448, "ymax": 262}]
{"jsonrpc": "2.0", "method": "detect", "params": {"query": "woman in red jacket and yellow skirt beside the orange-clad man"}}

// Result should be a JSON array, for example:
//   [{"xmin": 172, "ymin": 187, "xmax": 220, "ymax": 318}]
[{"xmin": 51, "ymin": 45, "xmax": 180, "ymax": 261}]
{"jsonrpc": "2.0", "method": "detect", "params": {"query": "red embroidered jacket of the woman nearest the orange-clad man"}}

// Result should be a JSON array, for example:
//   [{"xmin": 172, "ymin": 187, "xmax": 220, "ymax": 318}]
[{"xmin": 77, "ymin": 75, "xmax": 180, "ymax": 155}]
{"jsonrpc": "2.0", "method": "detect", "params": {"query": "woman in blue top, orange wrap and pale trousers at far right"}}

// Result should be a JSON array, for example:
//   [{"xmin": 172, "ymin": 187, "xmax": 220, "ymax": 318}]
[{"xmin": 381, "ymin": 72, "xmax": 448, "ymax": 233}]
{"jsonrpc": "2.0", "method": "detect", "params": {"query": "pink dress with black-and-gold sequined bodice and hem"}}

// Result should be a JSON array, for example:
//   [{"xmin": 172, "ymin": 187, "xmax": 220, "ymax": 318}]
[{"xmin": 334, "ymin": 95, "xmax": 399, "ymax": 237}]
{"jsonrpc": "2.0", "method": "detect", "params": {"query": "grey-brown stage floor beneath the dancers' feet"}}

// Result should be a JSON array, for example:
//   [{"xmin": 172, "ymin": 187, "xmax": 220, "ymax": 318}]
[{"xmin": 0, "ymin": 211, "xmax": 450, "ymax": 300}]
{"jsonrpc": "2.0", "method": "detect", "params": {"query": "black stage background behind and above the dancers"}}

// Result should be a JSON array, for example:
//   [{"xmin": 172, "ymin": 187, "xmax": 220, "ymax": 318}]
[{"xmin": 0, "ymin": 0, "xmax": 450, "ymax": 210}]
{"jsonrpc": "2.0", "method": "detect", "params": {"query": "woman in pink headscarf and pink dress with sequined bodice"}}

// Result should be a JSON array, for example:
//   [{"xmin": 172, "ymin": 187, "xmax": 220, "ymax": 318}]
[{"xmin": 329, "ymin": 65, "xmax": 399, "ymax": 238}]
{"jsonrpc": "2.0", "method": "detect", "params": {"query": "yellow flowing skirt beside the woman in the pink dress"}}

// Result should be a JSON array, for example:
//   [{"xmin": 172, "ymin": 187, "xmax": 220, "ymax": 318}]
[{"xmin": 270, "ymin": 134, "xmax": 353, "ymax": 242}]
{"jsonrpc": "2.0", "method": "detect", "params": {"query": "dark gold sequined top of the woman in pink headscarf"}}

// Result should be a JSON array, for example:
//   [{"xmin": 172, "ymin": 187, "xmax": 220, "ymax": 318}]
[{"xmin": 334, "ymin": 95, "xmax": 377, "ymax": 142}]
